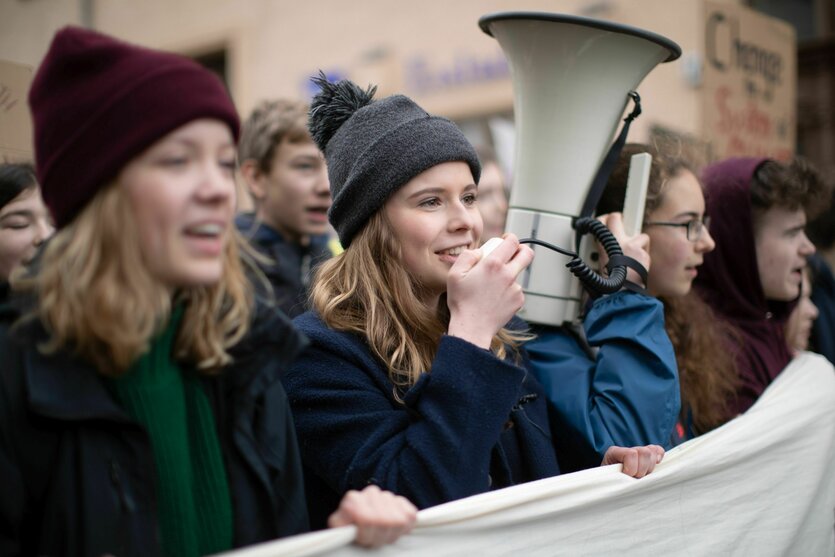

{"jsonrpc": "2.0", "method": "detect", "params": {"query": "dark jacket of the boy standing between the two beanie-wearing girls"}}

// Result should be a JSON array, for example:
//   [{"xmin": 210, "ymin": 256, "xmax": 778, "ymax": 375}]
[{"xmin": 235, "ymin": 213, "xmax": 332, "ymax": 318}]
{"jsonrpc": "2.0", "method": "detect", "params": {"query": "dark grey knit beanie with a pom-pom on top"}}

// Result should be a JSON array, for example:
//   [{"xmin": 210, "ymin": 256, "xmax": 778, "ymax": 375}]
[{"xmin": 309, "ymin": 73, "xmax": 481, "ymax": 248}]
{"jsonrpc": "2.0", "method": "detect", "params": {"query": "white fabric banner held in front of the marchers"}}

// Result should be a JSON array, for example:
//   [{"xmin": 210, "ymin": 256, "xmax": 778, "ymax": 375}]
[{"xmin": 222, "ymin": 353, "xmax": 835, "ymax": 557}]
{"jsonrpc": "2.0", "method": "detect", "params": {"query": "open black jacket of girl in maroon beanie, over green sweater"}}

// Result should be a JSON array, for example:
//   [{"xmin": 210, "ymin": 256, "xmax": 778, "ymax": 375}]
[{"xmin": 0, "ymin": 302, "xmax": 308, "ymax": 557}]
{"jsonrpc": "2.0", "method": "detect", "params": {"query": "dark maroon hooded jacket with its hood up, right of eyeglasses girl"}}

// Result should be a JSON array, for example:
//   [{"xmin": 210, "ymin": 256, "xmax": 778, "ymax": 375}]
[{"xmin": 695, "ymin": 158, "xmax": 796, "ymax": 414}]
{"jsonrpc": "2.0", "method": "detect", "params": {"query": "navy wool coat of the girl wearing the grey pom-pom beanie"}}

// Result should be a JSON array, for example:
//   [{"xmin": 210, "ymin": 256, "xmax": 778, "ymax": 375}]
[{"xmin": 283, "ymin": 312, "xmax": 559, "ymax": 527}]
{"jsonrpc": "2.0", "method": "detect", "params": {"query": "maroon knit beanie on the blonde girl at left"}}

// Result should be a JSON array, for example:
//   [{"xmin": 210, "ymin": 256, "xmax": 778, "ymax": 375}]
[{"xmin": 29, "ymin": 27, "xmax": 240, "ymax": 228}]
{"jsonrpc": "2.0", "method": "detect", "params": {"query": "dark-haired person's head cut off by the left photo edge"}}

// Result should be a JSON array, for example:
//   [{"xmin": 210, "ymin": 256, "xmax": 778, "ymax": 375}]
[{"xmin": 0, "ymin": 163, "xmax": 53, "ymax": 302}]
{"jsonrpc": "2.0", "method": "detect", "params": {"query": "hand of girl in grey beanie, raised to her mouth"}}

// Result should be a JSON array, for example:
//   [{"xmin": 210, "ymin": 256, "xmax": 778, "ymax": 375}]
[{"xmin": 447, "ymin": 234, "xmax": 533, "ymax": 349}]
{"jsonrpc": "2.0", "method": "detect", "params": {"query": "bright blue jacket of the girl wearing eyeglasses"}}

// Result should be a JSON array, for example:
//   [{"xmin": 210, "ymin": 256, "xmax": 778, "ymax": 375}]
[{"xmin": 525, "ymin": 292, "xmax": 681, "ymax": 469}]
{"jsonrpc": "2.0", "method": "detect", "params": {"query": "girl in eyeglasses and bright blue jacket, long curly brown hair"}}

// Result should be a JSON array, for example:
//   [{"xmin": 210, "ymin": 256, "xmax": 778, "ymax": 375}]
[{"xmin": 527, "ymin": 144, "xmax": 734, "ymax": 451}]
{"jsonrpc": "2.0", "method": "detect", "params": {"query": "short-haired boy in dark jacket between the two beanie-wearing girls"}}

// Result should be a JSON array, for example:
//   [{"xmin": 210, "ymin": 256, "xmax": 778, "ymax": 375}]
[{"xmin": 236, "ymin": 100, "xmax": 332, "ymax": 317}]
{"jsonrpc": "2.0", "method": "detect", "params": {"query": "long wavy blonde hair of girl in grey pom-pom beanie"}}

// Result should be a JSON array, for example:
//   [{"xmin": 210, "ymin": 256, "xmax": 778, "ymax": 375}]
[{"xmin": 310, "ymin": 211, "xmax": 531, "ymax": 401}]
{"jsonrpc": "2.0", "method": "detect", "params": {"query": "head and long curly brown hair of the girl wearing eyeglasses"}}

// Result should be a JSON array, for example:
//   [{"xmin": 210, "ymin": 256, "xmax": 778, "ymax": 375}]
[{"xmin": 598, "ymin": 144, "xmax": 737, "ymax": 444}]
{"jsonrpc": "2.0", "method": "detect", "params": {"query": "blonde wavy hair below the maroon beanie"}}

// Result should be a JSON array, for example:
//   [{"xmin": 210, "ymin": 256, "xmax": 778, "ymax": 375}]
[{"xmin": 14, "ymin": 184, "xmax": 253, "ymax": 376}]
